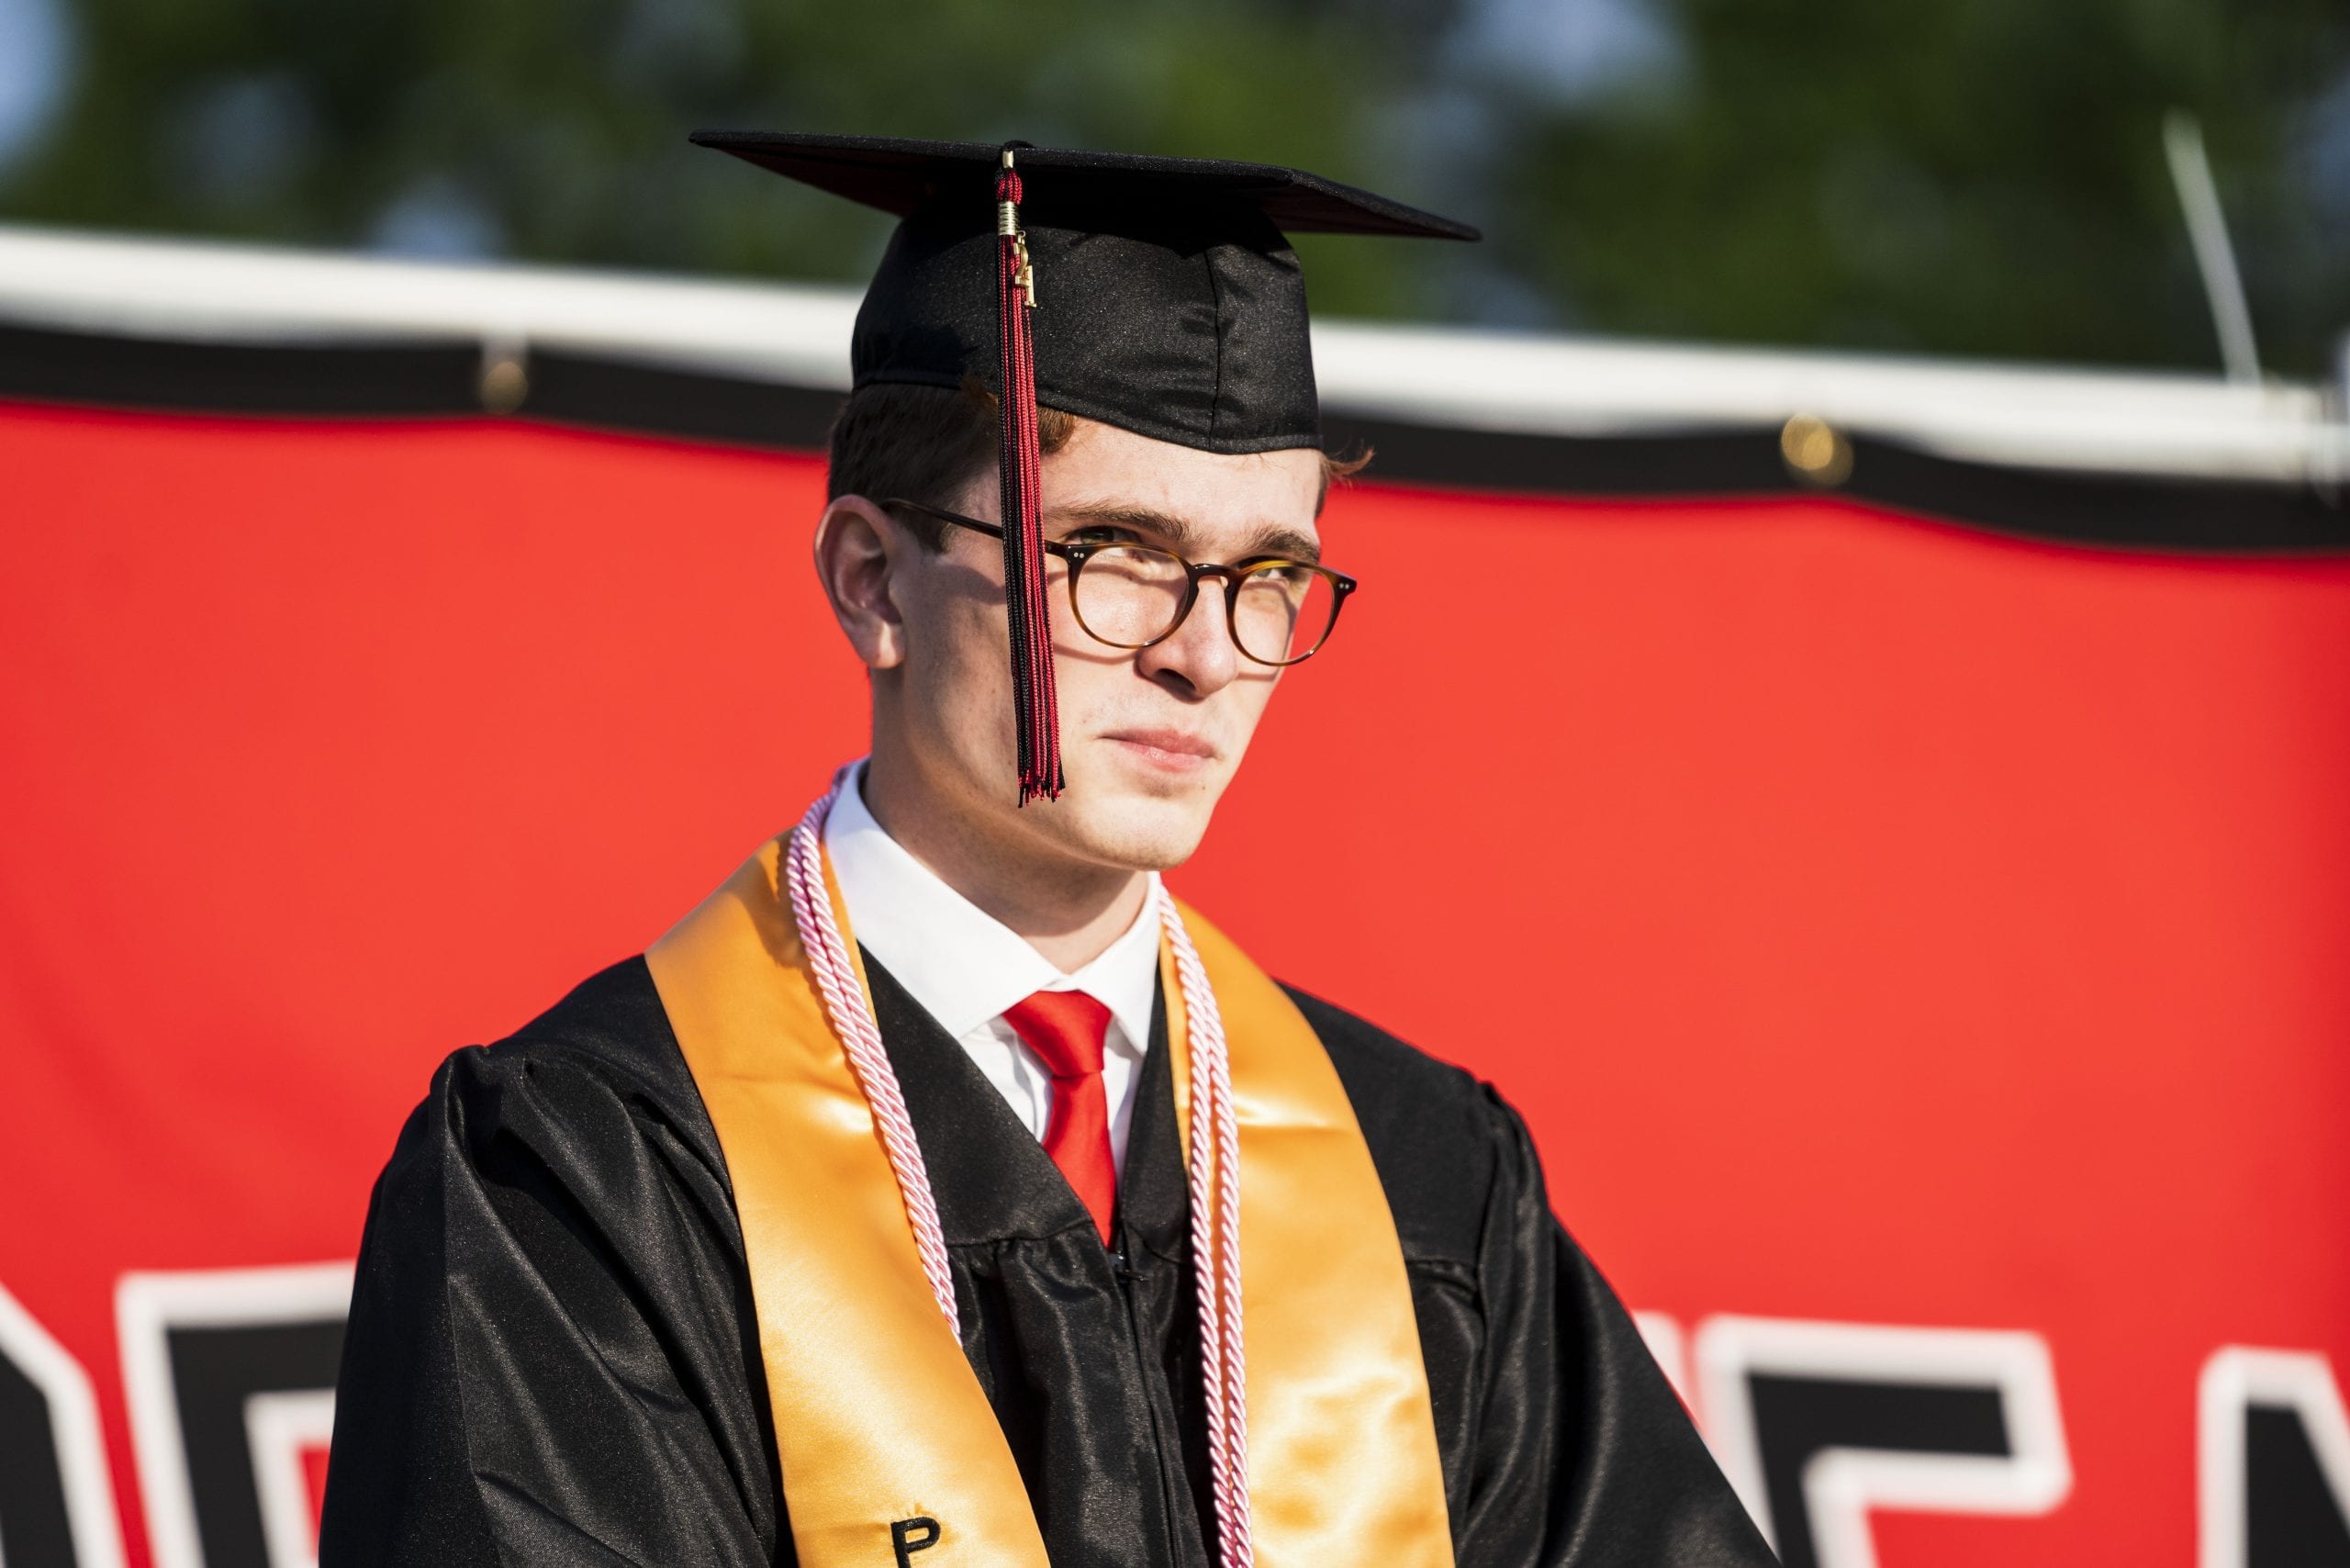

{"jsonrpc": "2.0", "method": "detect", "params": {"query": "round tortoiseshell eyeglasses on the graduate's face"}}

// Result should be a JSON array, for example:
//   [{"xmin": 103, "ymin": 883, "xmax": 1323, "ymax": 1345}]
[{"xmin": 881, "ymin": 498, "xmax": 1356, "ymax": 666}]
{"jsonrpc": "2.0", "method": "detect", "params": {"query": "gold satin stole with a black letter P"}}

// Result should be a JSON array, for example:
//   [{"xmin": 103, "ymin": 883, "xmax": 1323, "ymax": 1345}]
[{"xmin": 646, "ymin": 839, "xmax": 1452, "ymax": 1568}]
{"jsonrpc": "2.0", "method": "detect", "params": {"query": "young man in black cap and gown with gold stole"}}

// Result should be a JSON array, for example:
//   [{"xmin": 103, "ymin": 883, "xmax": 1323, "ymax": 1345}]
[{"xmin": 319, "ymin": 134, "xmax": 1772, "ymax": 1568}]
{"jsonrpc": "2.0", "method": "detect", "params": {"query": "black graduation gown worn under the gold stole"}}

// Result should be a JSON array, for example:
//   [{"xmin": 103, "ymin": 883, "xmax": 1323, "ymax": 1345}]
[{"xmin": 319, "ymin": 955, "xmax": 1772, "ymax": 1568}]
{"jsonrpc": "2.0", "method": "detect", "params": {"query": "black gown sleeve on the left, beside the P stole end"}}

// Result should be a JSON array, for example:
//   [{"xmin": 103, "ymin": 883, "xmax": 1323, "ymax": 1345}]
[{"xmin": 319, "ymin": 1005, "xmax": 789, "ymax": 1568}]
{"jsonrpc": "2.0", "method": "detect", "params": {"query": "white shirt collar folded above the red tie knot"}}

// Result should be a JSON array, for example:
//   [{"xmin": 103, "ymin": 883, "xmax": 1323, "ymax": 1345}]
[{"xmin": 825, "ymin": 767, "xmax": 1158, "ymax": 1058}]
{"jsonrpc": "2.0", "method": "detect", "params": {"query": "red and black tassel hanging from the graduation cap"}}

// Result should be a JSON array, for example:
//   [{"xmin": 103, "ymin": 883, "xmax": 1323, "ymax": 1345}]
[{"xmin": 996, "ymin": 148, "xmax": 1062, "ymax": 806}]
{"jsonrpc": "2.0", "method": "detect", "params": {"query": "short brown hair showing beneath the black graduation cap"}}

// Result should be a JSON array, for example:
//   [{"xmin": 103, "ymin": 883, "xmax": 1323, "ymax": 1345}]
[{"xmin": 825, "ymin": 381, "xmax": 1370, "ymax": 550}]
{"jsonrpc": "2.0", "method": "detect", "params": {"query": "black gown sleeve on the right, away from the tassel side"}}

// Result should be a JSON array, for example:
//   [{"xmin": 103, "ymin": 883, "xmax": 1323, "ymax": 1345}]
[{"xmin": 1457, "ymin": 1091, "xmax": 1776, "ymax": 1568}]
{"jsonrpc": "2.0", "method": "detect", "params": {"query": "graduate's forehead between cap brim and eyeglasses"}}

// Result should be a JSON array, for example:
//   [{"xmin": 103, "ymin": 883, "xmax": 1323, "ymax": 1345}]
[{"xmin": 1044, "ymin": 420, "xmax": 1323, "ymax": 538}]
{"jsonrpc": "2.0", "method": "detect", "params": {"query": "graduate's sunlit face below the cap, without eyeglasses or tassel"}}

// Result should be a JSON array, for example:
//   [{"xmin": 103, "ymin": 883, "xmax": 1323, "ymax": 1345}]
[{"xmin": 898, "ymin": 420, "xmax": 1323, "ymax": 869}]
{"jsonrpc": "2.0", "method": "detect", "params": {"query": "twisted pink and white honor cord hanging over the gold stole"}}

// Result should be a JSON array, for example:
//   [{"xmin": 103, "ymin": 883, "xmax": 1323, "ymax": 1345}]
[{"xmin": 782, "ymin": 764, "xmax": 1255, "ymax": 1568}]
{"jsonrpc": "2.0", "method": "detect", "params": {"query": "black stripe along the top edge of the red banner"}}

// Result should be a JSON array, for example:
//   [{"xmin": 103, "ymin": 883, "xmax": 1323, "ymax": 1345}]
[{"xmin": 0, "ymin": 327, "xmax": 2350, "ymax": 554}]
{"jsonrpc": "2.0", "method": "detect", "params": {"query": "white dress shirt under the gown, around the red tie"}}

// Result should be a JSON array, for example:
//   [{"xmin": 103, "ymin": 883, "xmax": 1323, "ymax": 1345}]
[{"xmin": 825, "ymin": 768, "xmax": 1158, "ymax": 1170}]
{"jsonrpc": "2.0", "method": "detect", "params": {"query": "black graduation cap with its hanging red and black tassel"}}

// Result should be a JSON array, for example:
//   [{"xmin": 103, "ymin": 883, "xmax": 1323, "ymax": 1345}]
[{"xmin": 693, "ymin": 131, "xmax": 1478, "ymax": 804}]
